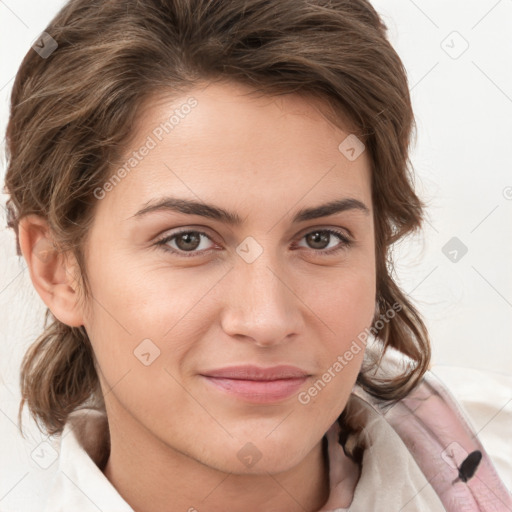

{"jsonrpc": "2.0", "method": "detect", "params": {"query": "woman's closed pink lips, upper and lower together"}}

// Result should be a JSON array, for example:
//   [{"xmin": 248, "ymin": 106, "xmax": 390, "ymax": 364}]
[{"xmin": 202, "ymin": 365, "xmax": 309, "ymax": 404}]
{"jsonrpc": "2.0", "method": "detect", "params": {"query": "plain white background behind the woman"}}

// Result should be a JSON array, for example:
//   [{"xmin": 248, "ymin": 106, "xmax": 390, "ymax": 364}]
[{"xmin": 0, "ymin": 0, "xmax": 512, "ymax": 510}]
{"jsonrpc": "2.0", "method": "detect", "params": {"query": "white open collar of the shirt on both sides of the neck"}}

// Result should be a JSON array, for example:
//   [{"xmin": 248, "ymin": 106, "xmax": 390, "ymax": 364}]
[{"xmin": 44, "ymin": 395, "xmax": 445, "ymax": 512}]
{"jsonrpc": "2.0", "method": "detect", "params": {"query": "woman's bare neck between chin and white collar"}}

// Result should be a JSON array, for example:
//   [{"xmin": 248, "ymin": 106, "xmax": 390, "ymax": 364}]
[{"xmin": 103, "ymin": 418, "xmax": 336, "ymax": 512}]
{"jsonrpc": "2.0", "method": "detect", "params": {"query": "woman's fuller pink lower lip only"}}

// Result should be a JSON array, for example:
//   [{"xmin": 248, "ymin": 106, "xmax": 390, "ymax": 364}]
[{"xmin": 203, "ymin": 375, "xmax": 308, "ymax": 404}]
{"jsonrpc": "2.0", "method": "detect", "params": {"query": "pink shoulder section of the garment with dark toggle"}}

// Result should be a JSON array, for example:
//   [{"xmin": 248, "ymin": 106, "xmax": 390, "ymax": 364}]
[{"xmin": 353, "ymin": 372, "xmax": 512, "ymax": 512}]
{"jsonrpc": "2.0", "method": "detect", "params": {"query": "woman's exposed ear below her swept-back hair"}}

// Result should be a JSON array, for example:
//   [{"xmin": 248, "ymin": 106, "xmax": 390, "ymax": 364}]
[{"xmin": 19, "ymin": 214, "xmax": 83, "ymax": 327}]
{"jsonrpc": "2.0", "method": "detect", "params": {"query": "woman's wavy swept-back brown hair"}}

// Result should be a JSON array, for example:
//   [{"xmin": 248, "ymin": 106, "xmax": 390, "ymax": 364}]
[{"xmin": 6, "ymin": 0, "xmax": 430, "ymax": 434}]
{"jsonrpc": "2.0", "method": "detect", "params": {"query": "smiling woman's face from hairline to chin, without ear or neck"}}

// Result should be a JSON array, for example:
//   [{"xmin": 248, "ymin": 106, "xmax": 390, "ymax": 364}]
[{"xmin": 83, "ymin": 83, "xmax": 376, "ymax": 473}]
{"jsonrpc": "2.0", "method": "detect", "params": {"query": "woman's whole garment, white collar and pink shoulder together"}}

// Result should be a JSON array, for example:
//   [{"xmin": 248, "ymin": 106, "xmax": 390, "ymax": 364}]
[{"xmin": 42, "ymin": 372, "xmax": 512, "ymax": 512}]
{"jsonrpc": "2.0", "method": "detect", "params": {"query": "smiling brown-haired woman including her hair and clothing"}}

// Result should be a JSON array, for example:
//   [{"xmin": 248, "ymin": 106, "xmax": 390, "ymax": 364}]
[{"xmin": 6, "ymin": 0, "xmax": 512, "ymax": 512}]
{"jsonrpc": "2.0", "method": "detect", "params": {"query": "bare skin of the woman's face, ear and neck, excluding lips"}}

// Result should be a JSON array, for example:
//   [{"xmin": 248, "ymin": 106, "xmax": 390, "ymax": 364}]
[{"xmin": 20, "ymin": 82, "xmax": 376, "ymax": 512}]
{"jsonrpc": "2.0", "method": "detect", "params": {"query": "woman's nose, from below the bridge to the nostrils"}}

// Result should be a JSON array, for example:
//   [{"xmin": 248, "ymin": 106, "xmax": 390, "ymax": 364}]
[{"xmin": 221, "ymin": 251, "xmax": 306, "ymax": 347}]
